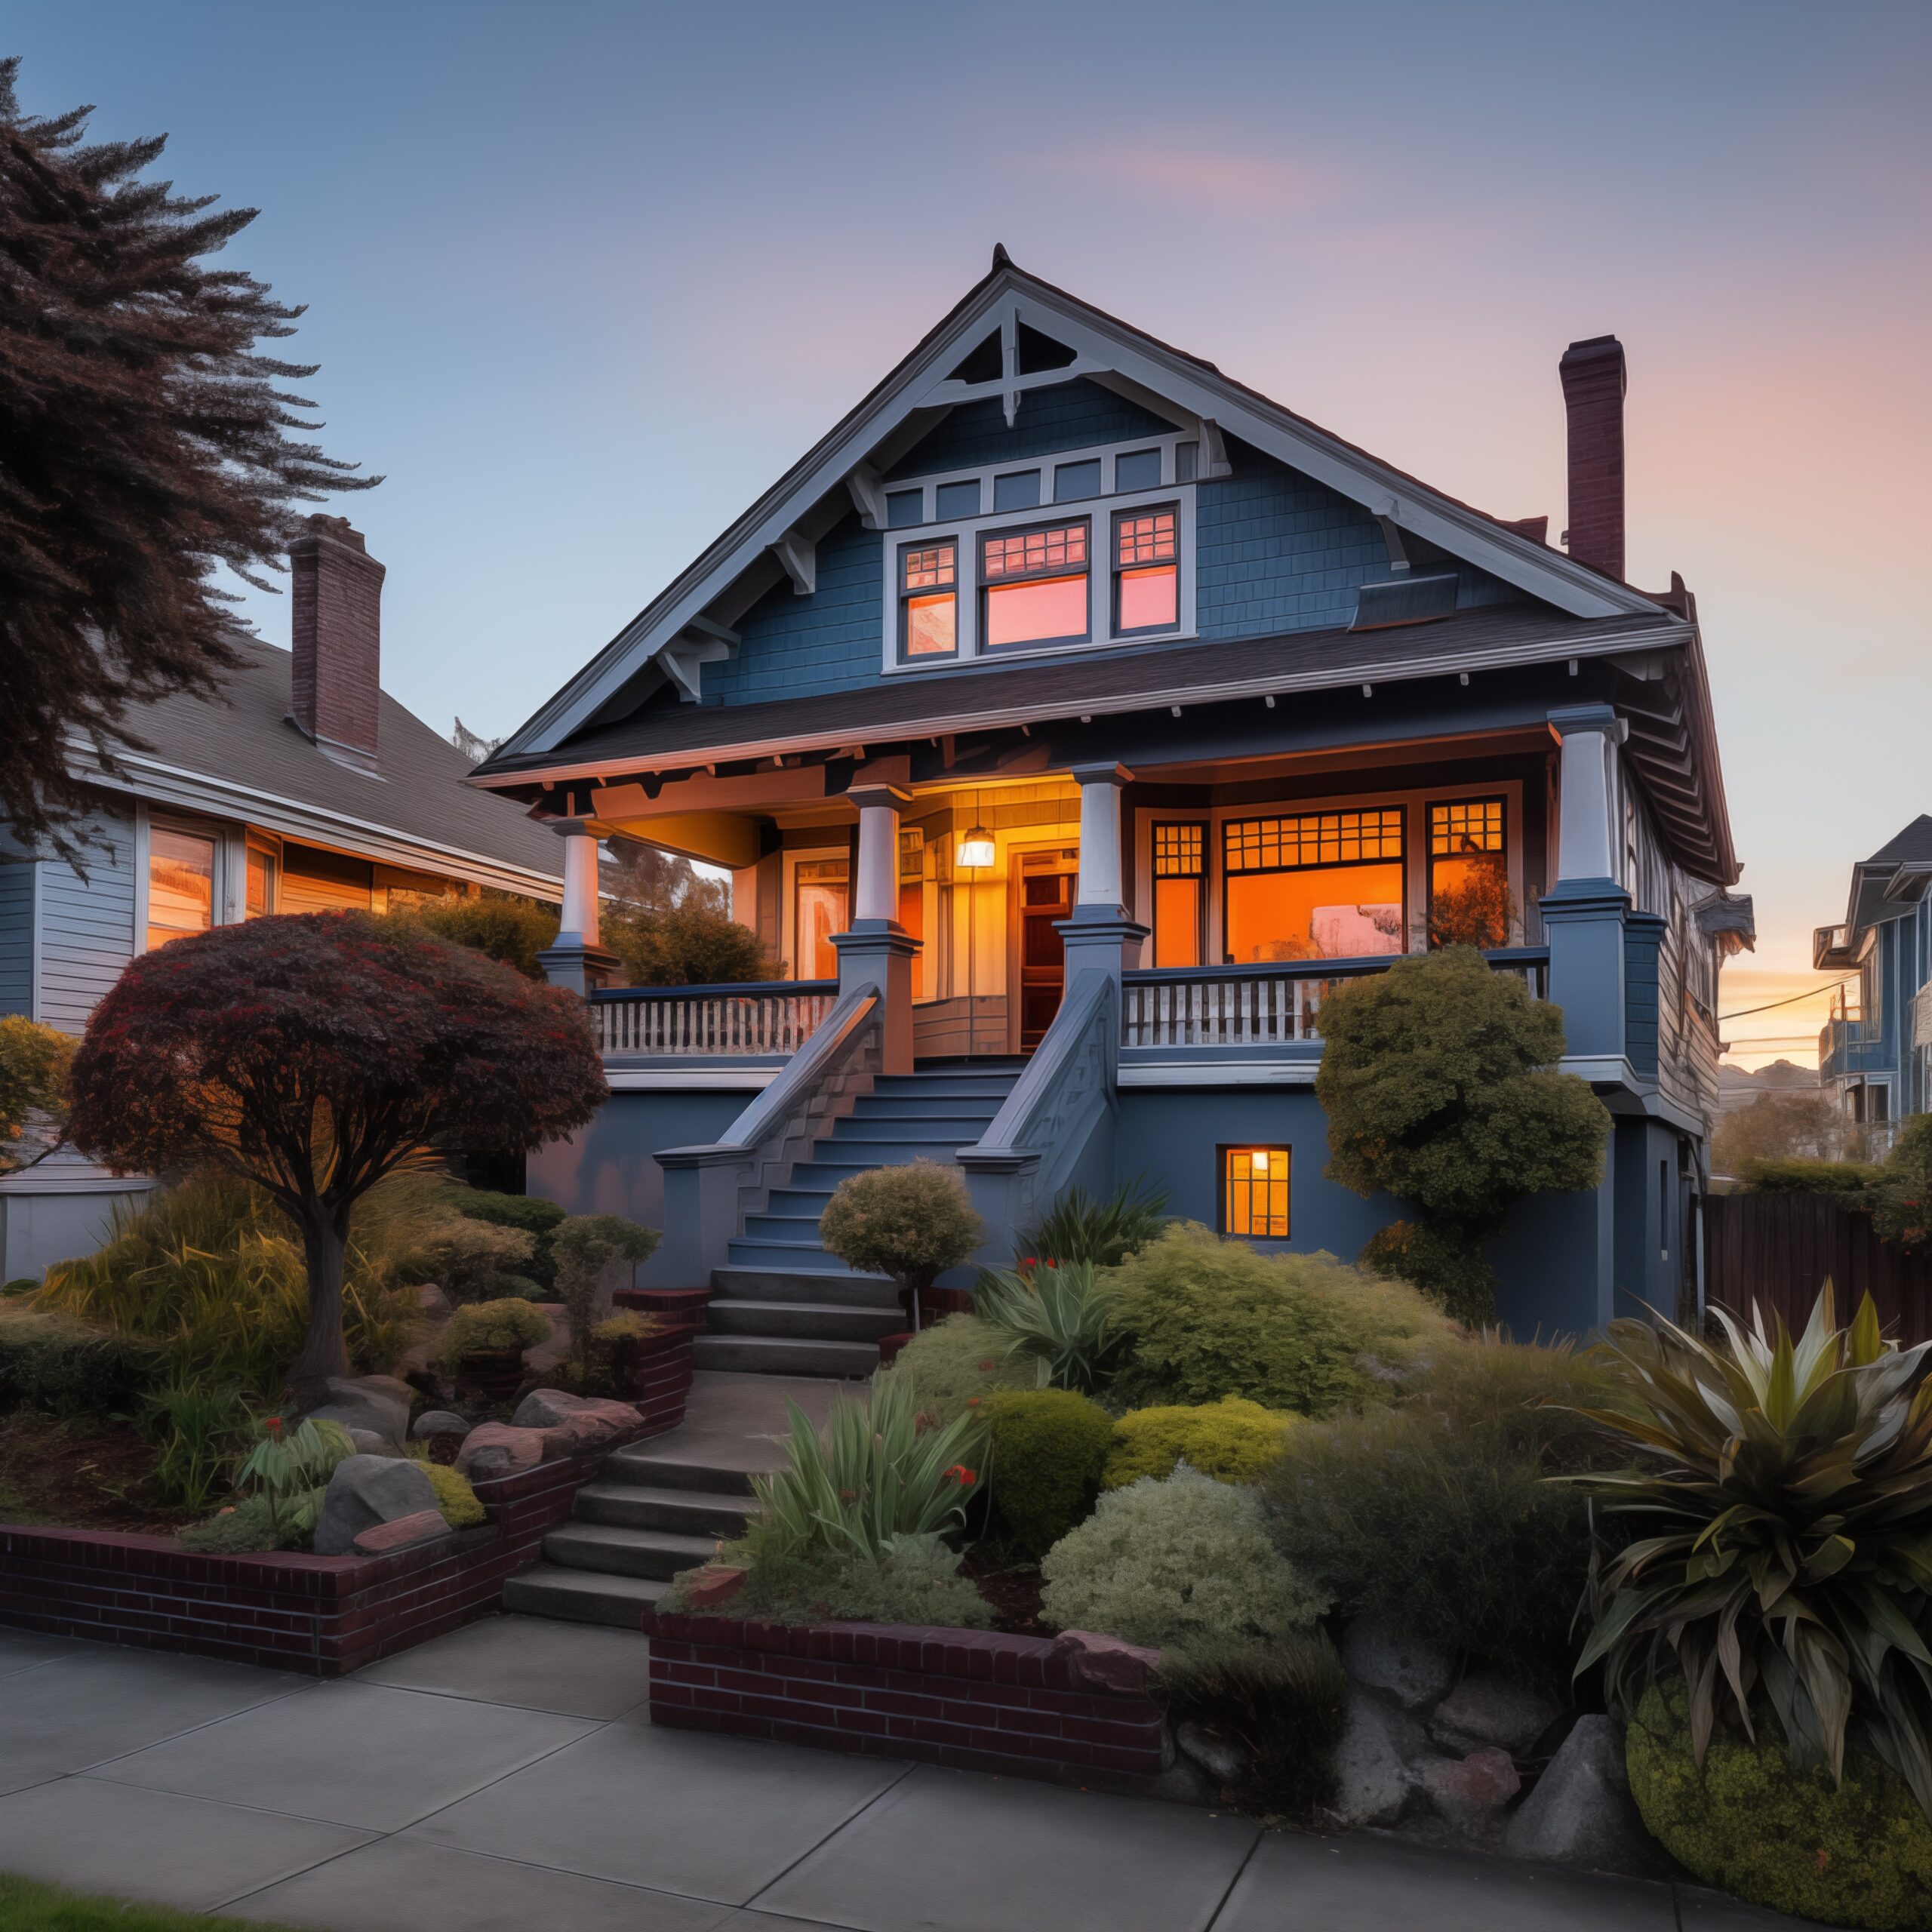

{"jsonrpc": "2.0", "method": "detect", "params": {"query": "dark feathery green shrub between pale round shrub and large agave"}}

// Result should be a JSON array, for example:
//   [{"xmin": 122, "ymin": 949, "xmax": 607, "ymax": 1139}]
[{"xmin": 1263, "ymin": 1339, "xmax": 1623, "ymax": 1690}]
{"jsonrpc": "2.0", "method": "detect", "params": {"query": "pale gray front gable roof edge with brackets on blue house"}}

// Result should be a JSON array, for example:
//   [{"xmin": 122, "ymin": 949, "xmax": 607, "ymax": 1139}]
[{"xmin": 477, "ymin": 249, "xmax": 1660, "ymax": 780}]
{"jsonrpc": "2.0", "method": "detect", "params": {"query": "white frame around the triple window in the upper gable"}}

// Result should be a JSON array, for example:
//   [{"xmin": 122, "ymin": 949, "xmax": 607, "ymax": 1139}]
[{"xmin": 881, "ymin": 431, "xmax": 1198, "ymax": 676}]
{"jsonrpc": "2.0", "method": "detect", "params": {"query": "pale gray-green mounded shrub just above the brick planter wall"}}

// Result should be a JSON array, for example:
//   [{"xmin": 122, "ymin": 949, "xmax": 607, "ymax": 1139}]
[{"xmin": 1039, "ymin": 1469, "xmax": 1327, "ymax": 1648}]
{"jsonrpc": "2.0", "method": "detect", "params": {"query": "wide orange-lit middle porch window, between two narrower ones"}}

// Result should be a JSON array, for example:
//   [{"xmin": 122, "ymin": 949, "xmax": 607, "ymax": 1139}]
[{"xmin": 1221, "ymin": 806, "xmax": 1407, "ymax": 966}]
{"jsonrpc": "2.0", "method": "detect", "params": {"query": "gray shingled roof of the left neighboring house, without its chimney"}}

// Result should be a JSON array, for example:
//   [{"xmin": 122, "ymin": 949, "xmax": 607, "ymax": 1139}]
[{"xmin": 73, "ymin": 632, "xmax": 562, "ymax": 897}]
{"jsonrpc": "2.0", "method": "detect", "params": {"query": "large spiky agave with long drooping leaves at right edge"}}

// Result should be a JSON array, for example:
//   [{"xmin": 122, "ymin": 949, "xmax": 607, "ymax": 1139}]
[{"xmin": 1565, "ymin": 1283, "xmax": 1932, "ymax": 1816}]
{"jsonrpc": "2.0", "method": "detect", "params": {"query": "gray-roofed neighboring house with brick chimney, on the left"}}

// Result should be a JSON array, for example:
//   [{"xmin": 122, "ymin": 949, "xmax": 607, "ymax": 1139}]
[{"xmin": 0, "ymin": 516, "xmax": 560, "ymax": 1279}]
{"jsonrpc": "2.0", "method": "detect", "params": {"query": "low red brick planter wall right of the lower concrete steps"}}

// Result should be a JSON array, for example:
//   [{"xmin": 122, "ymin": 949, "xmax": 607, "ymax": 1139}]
[{"xmin": 643, "ymin": 1614, "xmax": 1167, "ymax": 1787}]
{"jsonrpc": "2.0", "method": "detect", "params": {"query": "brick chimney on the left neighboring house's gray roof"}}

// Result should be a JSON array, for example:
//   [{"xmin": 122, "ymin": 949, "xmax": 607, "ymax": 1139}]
[{"xmin": 288, "ymin": 516, "xmax": 384, "ymax": 771}]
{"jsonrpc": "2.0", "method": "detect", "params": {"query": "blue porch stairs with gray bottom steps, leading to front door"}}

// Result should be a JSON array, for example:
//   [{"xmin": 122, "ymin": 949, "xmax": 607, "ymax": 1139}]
[{"xmin": 694, "ymin": 1060, "xmax": 1020, "ymax": 1376}]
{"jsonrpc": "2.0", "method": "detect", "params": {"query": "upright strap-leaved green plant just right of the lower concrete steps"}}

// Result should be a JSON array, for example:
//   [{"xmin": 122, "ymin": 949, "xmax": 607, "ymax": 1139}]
[{"xmin": 752, "ymin": 1377, "xmax": 981, "ymax": 1561}]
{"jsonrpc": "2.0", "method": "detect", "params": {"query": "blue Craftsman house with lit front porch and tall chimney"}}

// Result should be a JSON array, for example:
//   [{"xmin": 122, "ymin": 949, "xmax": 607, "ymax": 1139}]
[{"xmin": 472, "ymin": 251, "xmax": 1750, "ymax": 1366}]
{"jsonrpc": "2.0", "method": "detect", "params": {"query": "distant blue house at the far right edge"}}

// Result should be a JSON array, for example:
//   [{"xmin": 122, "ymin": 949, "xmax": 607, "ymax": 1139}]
[{"xmin": 1812, "ymin": 814, "xmax": 1932, "ymax": 1152}]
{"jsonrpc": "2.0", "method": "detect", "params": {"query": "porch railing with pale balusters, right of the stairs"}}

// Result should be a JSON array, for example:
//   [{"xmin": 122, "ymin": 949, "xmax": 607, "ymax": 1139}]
[{"xmin": 1121, "ymin": 946, "xmax": 1549, "ymax": 1048}]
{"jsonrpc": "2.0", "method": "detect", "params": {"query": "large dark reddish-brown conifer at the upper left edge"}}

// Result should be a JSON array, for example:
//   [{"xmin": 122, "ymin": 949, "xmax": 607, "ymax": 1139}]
[{"xmin": 0, "ymin": 58, "xmax": 380, "ymax": 852}]
